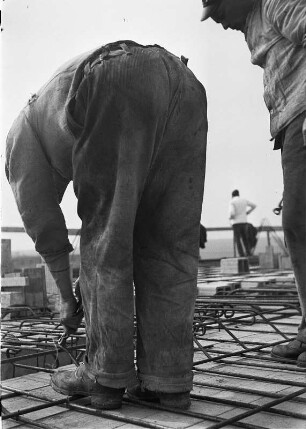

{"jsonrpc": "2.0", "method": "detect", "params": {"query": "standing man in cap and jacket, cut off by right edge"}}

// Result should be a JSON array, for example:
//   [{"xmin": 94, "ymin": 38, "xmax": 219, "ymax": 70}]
[{"xmin": 201, "ymin": 0, "xmax": 306, "ymax": 367}]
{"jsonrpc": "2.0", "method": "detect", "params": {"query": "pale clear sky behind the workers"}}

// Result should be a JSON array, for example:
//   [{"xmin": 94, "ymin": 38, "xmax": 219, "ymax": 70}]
[{"xmin": 1, "ymin": 0, "xmax": 283, "ymax": 249}]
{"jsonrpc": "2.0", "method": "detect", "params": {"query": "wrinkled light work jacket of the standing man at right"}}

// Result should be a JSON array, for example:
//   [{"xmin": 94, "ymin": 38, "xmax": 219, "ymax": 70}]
[{"xmin": 245, "ymin": 0, "xmax": 306, "ymax": 138}]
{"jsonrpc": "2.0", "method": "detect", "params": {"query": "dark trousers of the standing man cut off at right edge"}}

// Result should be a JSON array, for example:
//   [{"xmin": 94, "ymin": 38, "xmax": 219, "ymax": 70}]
[{"xmin": 282, "ymin": 112, "xmax": 306, "ymax": 326}]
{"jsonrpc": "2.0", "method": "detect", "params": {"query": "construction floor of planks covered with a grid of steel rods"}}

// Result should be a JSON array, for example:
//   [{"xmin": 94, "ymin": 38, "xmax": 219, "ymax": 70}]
[{"xmin": 1, "ymin": 265, "xmax": 306, "ymax": 429}]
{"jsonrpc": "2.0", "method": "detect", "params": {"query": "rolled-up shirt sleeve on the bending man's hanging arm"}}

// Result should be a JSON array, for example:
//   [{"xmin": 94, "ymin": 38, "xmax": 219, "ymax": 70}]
[{"xmin": 5, "ymin": 112, "xmax": 72, "ymax": 262}]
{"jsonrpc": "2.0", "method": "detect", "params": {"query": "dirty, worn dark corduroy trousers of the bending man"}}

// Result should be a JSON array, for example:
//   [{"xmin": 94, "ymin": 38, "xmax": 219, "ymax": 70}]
[{"xmin": 67, "ymin": 42, "xmax": 207, "ymax": 392}]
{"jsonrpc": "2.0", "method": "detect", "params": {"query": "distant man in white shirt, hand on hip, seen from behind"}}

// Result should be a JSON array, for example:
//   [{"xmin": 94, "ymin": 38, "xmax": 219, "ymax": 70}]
[{"xmin": 229, "ymin": 189, "xmax": 256, "ymax": 256}]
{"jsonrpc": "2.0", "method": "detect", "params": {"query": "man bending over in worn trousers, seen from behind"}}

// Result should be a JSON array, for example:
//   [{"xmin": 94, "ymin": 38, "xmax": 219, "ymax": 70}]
[{"xmin": 6, "ymin": 41, "xmax": 207, "ymax": 409}]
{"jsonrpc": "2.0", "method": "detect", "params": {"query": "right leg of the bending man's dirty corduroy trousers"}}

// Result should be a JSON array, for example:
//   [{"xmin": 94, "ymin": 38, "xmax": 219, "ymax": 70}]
[{"xmin": 134, "ymin": 70, "xmax": 207, "ymax": 392}]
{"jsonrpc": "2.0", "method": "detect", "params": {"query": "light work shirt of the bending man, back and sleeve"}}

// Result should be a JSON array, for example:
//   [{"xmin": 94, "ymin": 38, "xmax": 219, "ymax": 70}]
[{"xmin": 6, "ymin": 47, "xmax": 97, "ymax": 262}]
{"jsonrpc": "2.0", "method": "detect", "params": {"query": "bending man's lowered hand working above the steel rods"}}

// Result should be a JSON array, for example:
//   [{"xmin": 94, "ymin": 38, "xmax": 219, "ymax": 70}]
[{"xmin": 60, "ymin": 279, "xmax": 84, "ymax": 336}]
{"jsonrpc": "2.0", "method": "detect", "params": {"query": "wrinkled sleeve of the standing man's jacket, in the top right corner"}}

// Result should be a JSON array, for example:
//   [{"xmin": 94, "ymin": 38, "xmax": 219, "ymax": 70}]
[{"xmin": 263, "ymin": 0, "xmax": 306, "ymax": 47}]
